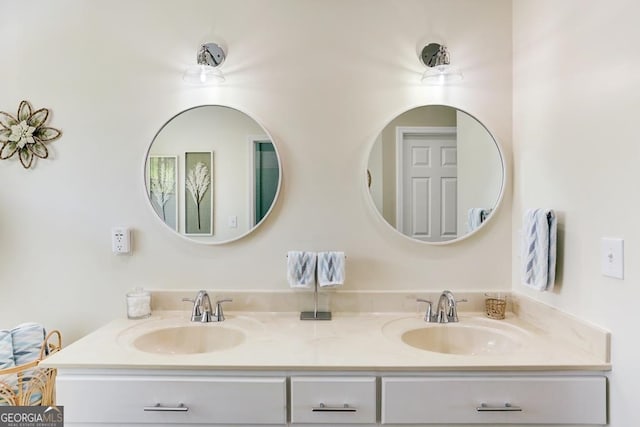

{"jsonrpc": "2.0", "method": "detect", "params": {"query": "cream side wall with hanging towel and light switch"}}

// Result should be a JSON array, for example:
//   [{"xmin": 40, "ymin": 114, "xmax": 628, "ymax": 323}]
[{"xmin": 513, "ymin": 0, "xmax": 640, "ymax": 427}]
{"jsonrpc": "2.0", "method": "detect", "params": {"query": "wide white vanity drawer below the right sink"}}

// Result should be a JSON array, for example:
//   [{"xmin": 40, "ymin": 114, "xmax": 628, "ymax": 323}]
[{"xmin": 382, "ymin": 377, "xmax": 607, "ymax": 425}]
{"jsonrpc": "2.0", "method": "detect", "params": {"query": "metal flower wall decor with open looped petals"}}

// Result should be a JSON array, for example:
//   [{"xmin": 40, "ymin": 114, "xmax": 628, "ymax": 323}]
[{"xmin": 0, "ymin": 101, "xmax": 62, "ymax": 169}]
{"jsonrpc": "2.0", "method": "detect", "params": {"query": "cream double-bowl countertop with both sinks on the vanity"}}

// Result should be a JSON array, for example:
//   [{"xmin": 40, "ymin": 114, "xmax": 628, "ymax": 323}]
[{"xmin": 42, "ymin": 311, "xmax": 611, "ymax": 371}]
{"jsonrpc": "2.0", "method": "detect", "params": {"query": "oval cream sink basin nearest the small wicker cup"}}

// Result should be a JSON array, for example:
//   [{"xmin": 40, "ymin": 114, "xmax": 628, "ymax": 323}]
[{"xmin": 401, "ymin": 324, "xmax": 522, "ymax": 355}]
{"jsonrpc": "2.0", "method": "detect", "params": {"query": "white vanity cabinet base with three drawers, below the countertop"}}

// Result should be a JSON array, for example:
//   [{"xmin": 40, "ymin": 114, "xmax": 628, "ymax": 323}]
[{"xmin": 56, "ymin": 369, "xmax": 607, "ymax": 427}]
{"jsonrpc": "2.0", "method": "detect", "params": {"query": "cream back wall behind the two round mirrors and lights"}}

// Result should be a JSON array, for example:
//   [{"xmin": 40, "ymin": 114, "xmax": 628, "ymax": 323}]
[{"xmin": 0, "ymin": 0, "xmax": 512, "ymax": 342}]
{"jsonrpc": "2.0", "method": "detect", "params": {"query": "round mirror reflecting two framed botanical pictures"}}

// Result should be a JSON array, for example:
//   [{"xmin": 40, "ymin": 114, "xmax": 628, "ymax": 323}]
[{"xmin": 145, "ymin": 105, "xmax": 282, "ymax": 244}]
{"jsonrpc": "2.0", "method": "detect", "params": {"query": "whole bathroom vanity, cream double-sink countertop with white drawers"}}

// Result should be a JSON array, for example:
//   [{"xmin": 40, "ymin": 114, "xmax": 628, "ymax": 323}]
[{"xmin": 46, "ymin": 294, "xmax": 610, "ymax": 426}]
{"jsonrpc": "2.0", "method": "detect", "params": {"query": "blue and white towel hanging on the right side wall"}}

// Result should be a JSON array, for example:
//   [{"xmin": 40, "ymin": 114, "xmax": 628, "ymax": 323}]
[{"xmin": 521, "ymin": 209, "xmax": 558, "ymax": 291}]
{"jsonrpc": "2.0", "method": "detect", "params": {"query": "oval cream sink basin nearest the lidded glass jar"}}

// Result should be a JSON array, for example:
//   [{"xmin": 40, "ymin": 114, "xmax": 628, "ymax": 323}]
[{"xmin": 132, "ymin": 324, "xmax": 245, "ymax": 354}]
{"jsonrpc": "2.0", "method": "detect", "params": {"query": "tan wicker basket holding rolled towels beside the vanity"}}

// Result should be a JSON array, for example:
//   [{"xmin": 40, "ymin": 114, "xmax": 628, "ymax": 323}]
[{"xmin": 0, "ymin": 330, "xmax": 62, "ymax": 406}]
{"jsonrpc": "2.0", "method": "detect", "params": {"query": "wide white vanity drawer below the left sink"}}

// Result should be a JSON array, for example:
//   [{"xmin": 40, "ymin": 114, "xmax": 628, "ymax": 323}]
[{"xmin": 56, "ymin": 375, "xmax": 287, "ymax": 425}]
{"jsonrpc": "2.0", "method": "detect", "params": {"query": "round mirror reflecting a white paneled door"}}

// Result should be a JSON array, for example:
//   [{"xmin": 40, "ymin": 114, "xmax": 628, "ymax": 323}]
[{"xmin": 366, "ymin": 105, "xmax": 505, "ymax": 244}]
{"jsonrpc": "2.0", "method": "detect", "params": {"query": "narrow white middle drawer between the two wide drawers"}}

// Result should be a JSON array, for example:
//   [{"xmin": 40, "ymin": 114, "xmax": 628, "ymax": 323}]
[{"xmin": 291, "ymin": 377, "xmax": 376, "ymax": 425}]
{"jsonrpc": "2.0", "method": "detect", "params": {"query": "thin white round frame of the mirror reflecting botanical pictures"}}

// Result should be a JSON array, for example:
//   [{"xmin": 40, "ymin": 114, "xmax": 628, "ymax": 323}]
[{"xmin": 142, "ymin": 104, "xmax": 283, "ymax": 246}]
